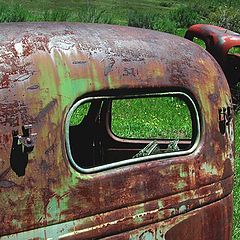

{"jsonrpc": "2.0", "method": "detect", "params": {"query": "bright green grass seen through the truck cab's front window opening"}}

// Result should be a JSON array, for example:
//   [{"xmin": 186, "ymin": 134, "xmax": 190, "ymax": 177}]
[{"xmin": 112, "ymin": 97, "xmax": 192, "ymax": 139}]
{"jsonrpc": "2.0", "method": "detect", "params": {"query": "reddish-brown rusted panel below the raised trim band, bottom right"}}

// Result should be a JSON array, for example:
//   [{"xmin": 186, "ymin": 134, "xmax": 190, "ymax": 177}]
[{"xmin": 103, "ymin": 193, "xmax": 233, "ymax": 240}]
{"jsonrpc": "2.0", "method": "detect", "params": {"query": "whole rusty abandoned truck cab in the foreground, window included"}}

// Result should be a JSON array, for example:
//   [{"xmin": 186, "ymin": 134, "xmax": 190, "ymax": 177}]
[{"xmin": 0, "ymin": 23, "xmax": 237, "ymax": 240}]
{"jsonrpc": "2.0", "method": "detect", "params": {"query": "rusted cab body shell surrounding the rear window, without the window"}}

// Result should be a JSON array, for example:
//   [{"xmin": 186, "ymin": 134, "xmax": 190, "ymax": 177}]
[{"xmin": 0, "ymin": 23, "xmax": 234, "ymax": 240}]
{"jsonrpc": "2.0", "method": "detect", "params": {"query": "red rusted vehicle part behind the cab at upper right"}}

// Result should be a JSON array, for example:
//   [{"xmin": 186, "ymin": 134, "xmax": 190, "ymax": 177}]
[{"xmin": 185, "ymin": 24, "xmax": 240, "ymax": 95}]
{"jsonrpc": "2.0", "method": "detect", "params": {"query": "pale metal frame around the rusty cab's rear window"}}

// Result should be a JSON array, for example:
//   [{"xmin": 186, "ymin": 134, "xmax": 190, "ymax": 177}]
[{"xmin": 65, "ymin": 91, "xmax": 201, "ymax": 174}]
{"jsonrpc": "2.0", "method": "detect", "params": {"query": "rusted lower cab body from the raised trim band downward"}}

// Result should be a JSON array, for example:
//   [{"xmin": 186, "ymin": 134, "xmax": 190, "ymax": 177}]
[{"xmin": 2, "ymin": 179, "xmax": 233, "ymax": 240}]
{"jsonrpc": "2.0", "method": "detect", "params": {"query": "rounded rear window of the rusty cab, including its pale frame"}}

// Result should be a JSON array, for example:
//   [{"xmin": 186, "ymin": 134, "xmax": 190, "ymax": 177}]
[{"xmin": 66, "ymin": 92, "xmax": 200, "ymax": 173}]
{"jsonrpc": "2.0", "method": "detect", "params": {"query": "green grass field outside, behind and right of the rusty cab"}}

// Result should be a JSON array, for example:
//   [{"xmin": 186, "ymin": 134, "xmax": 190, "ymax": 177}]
[{"xmin": 0, "ymin": 0, "xmax": 240, "ymax": 240}]
